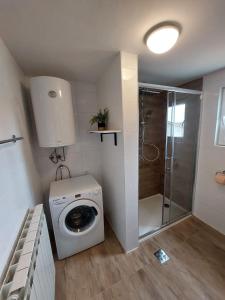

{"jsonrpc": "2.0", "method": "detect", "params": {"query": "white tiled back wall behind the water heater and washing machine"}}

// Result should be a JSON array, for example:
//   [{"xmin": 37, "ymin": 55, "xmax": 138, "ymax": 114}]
[{"xmin": 35, "ymin": 82, "xmax": 101, "ymax": 201}]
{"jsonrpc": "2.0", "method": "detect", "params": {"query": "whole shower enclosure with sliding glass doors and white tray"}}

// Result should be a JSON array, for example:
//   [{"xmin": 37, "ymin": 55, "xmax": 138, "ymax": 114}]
[{"xmin": 139, "ymin": 83, "xmax": 201, "ymax": 237}]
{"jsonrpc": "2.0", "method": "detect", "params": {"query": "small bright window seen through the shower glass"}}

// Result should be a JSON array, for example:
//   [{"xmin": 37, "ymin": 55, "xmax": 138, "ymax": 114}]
[{"xmin": 167, "ymin": 104, "xmax": 185, "ymax": 138}]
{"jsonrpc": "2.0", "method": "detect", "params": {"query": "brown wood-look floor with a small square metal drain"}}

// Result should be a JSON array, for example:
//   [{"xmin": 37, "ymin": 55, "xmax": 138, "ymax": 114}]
[{"xmin": 56, "ymin": 217, "xmax": 225, "ymax": 300}]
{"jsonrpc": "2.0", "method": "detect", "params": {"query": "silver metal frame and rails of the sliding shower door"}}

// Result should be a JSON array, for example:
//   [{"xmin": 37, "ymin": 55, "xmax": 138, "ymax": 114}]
[{"xmin": 138, "ymin": 82, "xmax": 202, "ymax": 238}]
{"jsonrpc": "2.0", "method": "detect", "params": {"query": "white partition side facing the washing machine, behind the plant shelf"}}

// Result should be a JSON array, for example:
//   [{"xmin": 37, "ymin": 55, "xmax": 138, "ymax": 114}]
[{"xmin": 97, "ymin": 55, "xmax": 126, "ymax": 248}]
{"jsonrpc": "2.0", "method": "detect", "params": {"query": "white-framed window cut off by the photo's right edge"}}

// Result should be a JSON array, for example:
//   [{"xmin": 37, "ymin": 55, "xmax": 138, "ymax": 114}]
[{"xmin": 215, "ymin": 87, "xmax": 225, "ymax": 146}]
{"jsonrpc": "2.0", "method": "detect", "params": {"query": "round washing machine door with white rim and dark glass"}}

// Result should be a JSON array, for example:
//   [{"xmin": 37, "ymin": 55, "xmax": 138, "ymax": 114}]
[{"xmin": 59, "ymin": 199, "xmax": 101, "ymax": 236}]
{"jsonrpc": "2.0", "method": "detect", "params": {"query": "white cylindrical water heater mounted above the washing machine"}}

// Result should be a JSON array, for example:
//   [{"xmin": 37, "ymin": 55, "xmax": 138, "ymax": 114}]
[{"xmin": 31, "ymin": 76, "xmax": 75, "ymax": 147}]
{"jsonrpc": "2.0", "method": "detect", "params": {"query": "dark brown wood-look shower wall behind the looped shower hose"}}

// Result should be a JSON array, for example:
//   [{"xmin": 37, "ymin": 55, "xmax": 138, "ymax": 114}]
[{"xmin": 139, "ymin": 93, "xmax": 166, "ymax": 199}]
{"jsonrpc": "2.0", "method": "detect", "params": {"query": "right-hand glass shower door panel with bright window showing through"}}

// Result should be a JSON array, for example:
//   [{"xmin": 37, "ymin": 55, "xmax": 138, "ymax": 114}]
[{"xmin": 162, "ymin": 92, "xmax": 200, "ymax": 225}]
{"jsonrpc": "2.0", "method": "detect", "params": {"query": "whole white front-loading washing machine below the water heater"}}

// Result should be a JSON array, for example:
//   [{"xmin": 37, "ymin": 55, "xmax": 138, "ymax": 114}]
[{"xmin": 49, "ymin": 175, "xmax": 104, "ymax": 259}]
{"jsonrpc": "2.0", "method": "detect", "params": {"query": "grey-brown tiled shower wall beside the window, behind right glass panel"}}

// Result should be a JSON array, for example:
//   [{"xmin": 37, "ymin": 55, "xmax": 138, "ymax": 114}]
[{"xmin": 172, "ymin": 79, "xmax": 202, "ymax": 211}]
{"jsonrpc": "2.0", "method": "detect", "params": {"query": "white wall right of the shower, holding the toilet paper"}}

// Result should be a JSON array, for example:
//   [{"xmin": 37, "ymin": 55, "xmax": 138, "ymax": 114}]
[{"xmin": 194, "ymin": 69, "xmax": 225, "ymax": 234}]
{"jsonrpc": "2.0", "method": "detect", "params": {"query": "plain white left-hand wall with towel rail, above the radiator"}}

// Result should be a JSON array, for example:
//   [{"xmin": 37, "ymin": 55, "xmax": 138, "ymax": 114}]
[{"xmin": 0, "ymin": 40, "xmax": 41, "ymax": 276}]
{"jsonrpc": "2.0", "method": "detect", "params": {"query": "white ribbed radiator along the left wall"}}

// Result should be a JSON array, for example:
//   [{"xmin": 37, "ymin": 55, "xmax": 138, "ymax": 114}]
[{"xmin": 0, "ymin": 204, "xmax": 55, "ymax": 300}]
